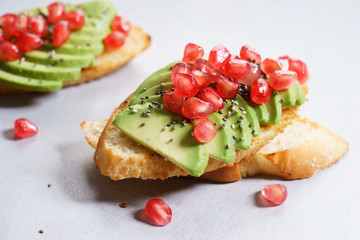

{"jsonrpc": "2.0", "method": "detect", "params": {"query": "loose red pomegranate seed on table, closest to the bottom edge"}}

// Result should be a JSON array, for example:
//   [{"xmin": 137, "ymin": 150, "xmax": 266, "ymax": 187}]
[{"xmin": 145, "ymin": 198, "xmax": 172, "ymax": 226}]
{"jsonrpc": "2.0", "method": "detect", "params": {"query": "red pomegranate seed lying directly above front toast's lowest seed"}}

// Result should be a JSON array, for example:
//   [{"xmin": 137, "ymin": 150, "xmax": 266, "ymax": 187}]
[{"xmin": 181, "ymin": 97, "xmax": 213, "ymax": 119}]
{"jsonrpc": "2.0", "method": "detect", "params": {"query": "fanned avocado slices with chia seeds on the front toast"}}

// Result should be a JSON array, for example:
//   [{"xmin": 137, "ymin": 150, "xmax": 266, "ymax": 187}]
[{"xmin": 113, "ymin": 62, "xmax": 305, "ymax": 176}]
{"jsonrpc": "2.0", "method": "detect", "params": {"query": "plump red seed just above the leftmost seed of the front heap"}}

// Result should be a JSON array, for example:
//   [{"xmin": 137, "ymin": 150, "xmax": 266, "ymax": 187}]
[{"xmin": 174, "ymin": 73, "xmax": 199, "ymax": 97}]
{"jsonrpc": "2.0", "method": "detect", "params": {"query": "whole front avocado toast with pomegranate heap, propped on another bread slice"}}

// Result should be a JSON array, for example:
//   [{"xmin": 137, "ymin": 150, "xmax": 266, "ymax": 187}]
[{"xmin": 82, "ymin": 43, "xmax": 348, "ymax": 181}]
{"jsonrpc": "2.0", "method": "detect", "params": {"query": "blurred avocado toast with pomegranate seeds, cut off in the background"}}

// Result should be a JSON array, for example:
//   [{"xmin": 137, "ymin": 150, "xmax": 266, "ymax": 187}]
[{"xmin": 0, "ymin": 0, "xmax": 150, "ymax": 94}]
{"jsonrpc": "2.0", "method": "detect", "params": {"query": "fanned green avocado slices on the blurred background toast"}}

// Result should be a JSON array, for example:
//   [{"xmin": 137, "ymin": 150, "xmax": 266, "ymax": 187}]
[{"xmin": 0, "ymin": 0, "xmax": 116, "ymax": 92}]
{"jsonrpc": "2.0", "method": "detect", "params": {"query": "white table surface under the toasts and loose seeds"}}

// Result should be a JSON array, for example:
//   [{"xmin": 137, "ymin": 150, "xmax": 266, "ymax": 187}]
[{"xmin": 0, "ymin": 0, "xmax": 360, "ymax": 240}]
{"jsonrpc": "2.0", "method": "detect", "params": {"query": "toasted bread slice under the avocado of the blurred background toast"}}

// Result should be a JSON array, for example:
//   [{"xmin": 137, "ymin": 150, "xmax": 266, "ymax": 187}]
[{"xmin": 0, "ymin": 26, "xmax": 151, "ymax": 94}]
